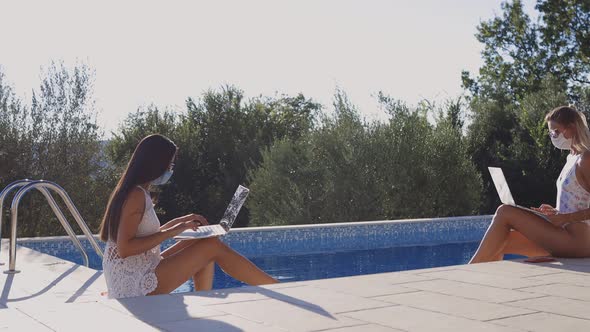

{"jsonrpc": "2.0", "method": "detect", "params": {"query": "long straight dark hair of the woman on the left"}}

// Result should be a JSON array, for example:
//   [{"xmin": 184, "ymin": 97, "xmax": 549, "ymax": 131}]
[{"xmin": 100, "ymin": 134, "xmax": 177, "ymax": 242}]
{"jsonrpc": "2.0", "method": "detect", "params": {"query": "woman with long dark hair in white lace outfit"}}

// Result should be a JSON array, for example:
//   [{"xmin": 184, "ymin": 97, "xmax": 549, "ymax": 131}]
[{"xmin": 100, "ymin": 135, "xmax": 277, "ymax": 298}]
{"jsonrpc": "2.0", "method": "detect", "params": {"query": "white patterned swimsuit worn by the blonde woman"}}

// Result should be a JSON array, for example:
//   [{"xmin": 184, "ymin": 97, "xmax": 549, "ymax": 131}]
[{"xmin": 555, "ymin": 154, "xmax": 590, "ymax": 224}]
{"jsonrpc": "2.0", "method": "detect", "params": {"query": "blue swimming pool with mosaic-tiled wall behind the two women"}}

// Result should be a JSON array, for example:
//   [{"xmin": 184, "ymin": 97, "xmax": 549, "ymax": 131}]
[{"xmin": 17, "ymin": 216, "xmax": 498, "ymax": 292}]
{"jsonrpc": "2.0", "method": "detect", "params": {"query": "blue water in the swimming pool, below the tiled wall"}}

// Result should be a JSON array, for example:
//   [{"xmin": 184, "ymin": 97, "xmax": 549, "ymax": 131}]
[{"xmin": 22, "ymin": 240, "xmax": 478, "ymax": 292}]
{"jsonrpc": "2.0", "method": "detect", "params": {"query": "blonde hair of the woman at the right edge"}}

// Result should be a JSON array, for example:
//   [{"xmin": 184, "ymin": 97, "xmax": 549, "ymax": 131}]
[{"xmin": 545, "ymin": 106, "xmax": 590, "ymax": 152}]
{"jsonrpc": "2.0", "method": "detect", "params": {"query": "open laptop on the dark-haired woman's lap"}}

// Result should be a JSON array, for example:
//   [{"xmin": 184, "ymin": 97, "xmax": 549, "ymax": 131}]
[{"xmin": 174, "ymin": 186, "xmax": 250, "ymax": 240}]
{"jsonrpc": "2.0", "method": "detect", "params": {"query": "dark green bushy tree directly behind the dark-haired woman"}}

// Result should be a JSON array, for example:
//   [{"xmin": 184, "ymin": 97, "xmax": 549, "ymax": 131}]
[{"xmin": 109, "ymin": 86, "xmax": 320, "ymax": 226}]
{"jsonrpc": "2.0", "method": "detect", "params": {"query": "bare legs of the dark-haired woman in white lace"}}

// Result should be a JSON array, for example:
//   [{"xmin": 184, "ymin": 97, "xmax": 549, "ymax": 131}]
[{"xmin": 150, "ymin": 238, "xmax": 278, "ymax": 295}]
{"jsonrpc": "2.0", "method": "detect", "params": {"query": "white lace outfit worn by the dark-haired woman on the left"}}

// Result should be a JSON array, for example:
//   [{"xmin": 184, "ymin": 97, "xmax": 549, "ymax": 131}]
[{"xmin": 102, "ymin": 187, "xmax": 162, "ymax": 298}]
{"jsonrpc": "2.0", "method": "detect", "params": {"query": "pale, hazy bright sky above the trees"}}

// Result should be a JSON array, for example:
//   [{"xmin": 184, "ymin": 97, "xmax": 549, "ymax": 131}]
[{"xmin": 0, "ymin": 0, "xmax": 535, "ymax": 136}]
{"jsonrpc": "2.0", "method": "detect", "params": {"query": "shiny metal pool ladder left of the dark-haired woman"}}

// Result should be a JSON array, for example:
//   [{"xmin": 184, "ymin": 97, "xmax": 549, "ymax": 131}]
[{"xmin": 0, "ymin": 179, "xmax": 102, "ymax": 274}]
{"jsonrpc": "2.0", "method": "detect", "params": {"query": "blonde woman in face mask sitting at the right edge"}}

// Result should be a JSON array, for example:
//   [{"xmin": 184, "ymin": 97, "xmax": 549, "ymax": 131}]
[{"xmin": 469, "ymin": 106, "xmax": 590, "ymax": 263}]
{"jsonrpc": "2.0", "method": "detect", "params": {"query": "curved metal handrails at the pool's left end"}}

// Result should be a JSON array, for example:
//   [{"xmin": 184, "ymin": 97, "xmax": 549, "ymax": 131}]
[{"xmin": 5, "ymin": 180, "xmax": 103, "ymax": 273}]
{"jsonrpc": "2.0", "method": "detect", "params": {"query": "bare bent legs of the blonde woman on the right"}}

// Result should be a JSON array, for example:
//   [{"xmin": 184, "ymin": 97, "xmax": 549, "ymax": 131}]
[{"xmin": 469, "ymin": 205, "xmax": 588, "ymax": 264}]
